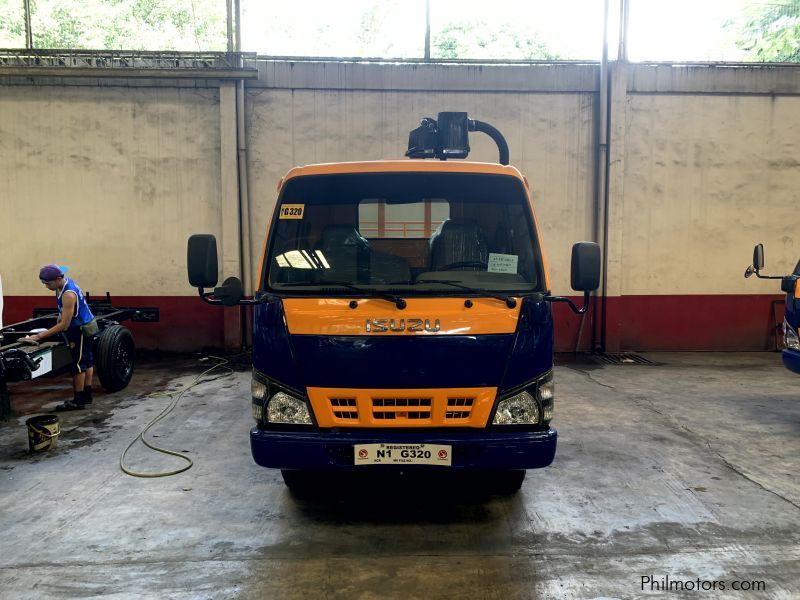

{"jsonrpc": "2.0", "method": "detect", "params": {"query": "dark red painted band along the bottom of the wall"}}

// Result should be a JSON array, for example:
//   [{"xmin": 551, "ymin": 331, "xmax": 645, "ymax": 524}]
[{"xmin": 3, "ymin": 295, "xmax": 783, "ymax": 352}]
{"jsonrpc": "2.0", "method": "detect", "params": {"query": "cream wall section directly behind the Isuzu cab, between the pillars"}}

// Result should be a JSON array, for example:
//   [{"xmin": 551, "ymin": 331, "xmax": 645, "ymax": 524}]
[{"xmin": 247, "ymin": 61, "xmax": 598, "ymax": 349}]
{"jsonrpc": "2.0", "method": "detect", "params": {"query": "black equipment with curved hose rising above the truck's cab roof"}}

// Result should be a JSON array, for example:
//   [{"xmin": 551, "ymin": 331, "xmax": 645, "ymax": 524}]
[{"xmin": 406, "ymin": 112, "xmax": 508, "ymax": 165}]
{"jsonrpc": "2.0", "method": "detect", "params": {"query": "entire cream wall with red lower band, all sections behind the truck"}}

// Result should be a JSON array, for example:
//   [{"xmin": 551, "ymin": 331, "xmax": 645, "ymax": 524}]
[{"xmin": 0, "ymin": 60, "xmax": 800, "ymax": 350}]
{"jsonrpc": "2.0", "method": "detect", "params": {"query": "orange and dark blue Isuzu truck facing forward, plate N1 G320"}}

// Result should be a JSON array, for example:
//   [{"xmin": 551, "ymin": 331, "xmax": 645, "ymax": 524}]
[{"xmin": 188, "ymin": 112, "xmax": 600, "ymax": 493}]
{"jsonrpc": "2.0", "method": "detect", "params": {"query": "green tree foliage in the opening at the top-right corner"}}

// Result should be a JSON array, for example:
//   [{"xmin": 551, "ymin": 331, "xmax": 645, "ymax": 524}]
[{"xmin": 726, "ymin": 0, "xmax": 800, "ymax": 62}]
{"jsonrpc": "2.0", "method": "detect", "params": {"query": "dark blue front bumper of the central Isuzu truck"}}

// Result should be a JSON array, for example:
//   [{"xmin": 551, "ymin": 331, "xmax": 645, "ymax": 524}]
[{"xmin": 250, "ymin": 427, "xmax": 558, "ymax": 470}]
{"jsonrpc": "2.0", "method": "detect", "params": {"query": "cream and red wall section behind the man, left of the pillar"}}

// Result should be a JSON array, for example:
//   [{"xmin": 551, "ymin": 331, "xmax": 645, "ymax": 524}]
[{"xmin": 0, "ymin": 85, "xmax": 221, "ymax": 349}]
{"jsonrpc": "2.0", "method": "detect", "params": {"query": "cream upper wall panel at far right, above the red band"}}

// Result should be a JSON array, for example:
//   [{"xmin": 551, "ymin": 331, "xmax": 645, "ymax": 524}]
[{"xmin": 621, "ymin": 94, "xmax": 800, "ymax": 295}]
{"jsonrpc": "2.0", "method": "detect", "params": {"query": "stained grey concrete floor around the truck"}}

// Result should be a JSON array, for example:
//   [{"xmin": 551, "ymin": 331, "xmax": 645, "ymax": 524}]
[{"xmin": 0, "ymin": 353, "xmax": 800, "ymax": 599}]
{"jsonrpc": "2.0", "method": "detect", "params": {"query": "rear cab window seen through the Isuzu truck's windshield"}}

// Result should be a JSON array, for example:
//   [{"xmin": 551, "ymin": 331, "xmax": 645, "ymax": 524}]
[{"xmin": 358, "ymin": 198, "xmax": 450, "ymax": 239}]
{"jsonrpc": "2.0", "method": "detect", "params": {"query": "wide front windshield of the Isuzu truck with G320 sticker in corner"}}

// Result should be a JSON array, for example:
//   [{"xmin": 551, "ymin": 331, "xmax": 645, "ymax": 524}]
[{"xmin": 262, "ymin": 173, "xmax": 544, "ymax": 295}]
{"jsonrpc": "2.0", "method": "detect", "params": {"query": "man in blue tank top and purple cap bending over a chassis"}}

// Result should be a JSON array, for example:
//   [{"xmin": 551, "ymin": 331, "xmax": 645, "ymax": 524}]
[{"xmin": 31, "ymin": 264, "xmax": 97, "ymax": 411}]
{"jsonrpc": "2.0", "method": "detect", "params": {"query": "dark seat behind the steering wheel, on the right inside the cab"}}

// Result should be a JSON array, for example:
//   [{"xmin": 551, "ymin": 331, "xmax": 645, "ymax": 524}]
[{"xmin": 429, "ymin": 219, "xmax": 489, "ymax": 271}]
